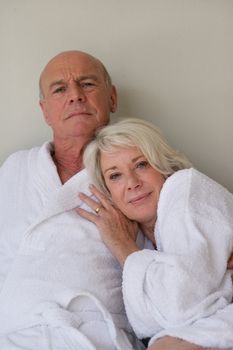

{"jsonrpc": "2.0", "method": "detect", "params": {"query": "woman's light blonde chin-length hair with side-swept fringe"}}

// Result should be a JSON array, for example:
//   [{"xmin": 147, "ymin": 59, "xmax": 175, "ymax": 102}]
[{"xmin": 84, "ymin": 118, "xmax": 192, "ymax": 194}]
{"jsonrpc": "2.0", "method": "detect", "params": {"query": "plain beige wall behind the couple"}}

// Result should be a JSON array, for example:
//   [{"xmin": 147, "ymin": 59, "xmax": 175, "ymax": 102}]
[{"xmin": 0, "ymin": 0, "xmax": 233, "ymax": 192}]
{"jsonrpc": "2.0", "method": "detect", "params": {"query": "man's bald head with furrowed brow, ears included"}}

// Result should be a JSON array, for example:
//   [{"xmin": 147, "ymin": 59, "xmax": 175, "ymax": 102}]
[{"xmin": 40, "ymin": 51, "xmax": 116, "ymax": 140}]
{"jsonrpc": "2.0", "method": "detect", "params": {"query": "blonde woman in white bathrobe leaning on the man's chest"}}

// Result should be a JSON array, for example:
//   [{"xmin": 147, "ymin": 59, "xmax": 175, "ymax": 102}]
[{"xmin": 77, "ymin": 119, "xmax": 233, "ymax": 349}]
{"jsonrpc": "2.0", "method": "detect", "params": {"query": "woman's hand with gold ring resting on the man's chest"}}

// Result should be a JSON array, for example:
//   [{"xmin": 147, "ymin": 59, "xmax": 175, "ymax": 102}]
[{"xmin": 76, "ymin": 185, "xmax": 139, "ymax": 266}]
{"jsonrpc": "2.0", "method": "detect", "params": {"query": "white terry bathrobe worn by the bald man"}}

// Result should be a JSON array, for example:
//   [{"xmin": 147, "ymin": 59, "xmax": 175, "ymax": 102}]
[{"xmin": 0, "ymin": 143, "xmax": 146, "ymax": 350}]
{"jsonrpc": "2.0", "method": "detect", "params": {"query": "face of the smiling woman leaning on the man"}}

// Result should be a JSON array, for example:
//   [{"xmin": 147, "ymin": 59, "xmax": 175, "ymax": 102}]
[{"xmin": 100, "ymin": 147, "xmax": 165, "ymax": 227}]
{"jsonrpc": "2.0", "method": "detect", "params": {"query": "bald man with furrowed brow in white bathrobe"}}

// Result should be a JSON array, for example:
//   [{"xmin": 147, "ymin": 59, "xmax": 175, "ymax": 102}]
[{"xmin": 0, "ymin": 51, "xmax": 215, "ymax": 350}]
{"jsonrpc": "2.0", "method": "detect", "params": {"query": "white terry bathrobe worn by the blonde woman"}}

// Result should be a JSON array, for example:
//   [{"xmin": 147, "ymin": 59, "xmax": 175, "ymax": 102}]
[{"xmin": 123, "ymin": 169, "xmax": 233, "ymax": 349}]
